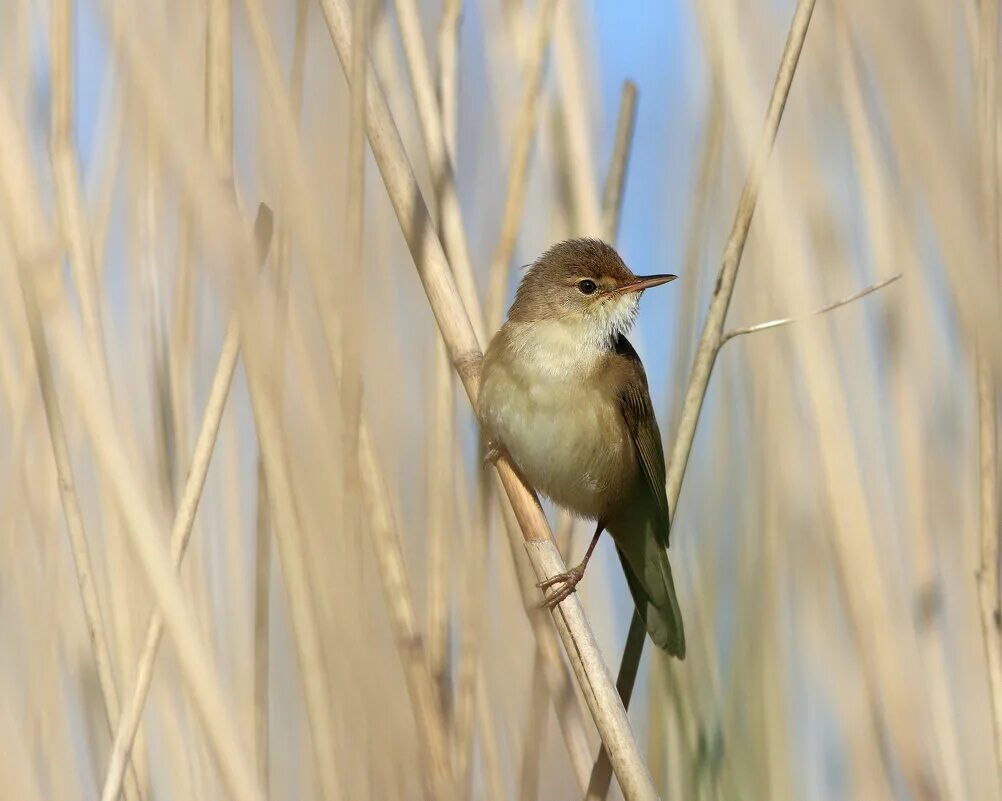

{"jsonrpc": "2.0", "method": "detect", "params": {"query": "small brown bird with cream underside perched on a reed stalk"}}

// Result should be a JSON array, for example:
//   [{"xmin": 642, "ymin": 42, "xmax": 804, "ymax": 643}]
[{"xmin": 477, "ymin": 239, "xmax": 685, "ymax": 659}]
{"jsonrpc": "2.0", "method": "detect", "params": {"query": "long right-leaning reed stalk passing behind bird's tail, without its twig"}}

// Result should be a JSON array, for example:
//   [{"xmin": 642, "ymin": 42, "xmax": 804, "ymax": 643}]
[{"xmin": 588, "ymin": 0, "xmax": 815, "ymax": 799}]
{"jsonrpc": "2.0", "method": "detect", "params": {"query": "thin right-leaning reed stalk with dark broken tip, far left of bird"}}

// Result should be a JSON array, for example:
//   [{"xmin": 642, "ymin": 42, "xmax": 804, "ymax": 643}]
[{"xmin": 101, "ymin": 207, "xmax": 272, "ymax": 801}]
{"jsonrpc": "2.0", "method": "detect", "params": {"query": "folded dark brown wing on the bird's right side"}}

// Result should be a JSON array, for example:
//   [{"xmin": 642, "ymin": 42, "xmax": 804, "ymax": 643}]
[{"xmin": 616, "ymin": 337, "xmax": 669, "ymax": 547}]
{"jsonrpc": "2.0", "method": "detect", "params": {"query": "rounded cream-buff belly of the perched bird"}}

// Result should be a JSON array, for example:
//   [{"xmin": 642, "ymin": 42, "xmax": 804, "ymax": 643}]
[{"xmin": 481, "ymin": 368, "xmax": 635, "ymax": 519}]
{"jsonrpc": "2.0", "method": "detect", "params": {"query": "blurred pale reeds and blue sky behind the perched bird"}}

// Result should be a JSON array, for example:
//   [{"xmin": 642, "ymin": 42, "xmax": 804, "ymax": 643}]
[{"xmin": 0, "ymin": 0, "xmax": 1002, "ymax": 801}]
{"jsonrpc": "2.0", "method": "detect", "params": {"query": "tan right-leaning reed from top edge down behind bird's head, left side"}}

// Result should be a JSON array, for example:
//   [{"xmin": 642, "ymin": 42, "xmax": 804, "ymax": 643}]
[{"xmin": 481, "ymin": 0, "xmax": 557, "ymax": 332}]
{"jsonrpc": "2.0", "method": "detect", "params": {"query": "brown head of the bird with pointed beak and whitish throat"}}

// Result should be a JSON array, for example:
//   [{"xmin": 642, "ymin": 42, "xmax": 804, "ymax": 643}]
[{"xmin": 508, "ymin": 239, "xmax": 675, "ymax": 344}]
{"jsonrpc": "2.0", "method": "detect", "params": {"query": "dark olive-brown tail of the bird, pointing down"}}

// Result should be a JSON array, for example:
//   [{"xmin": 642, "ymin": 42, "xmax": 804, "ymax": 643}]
[{"xmin": 613, "ymin": 525, "xmax": 685, "ymax": 659}]
